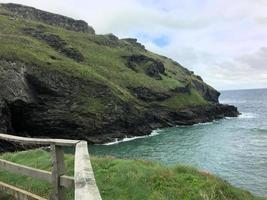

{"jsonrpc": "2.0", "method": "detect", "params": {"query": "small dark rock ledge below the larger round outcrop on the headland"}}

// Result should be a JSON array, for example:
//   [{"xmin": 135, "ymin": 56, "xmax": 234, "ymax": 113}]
[{"xmin": 130, "ymin": 87, "xmax": 171, "ymax": 102}]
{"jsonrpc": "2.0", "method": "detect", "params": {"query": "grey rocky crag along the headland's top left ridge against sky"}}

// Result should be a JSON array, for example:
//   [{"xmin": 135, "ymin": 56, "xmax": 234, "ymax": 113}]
[{"xmin": 1, "ymin": 3, "xmax": 95, "ymax": 34}]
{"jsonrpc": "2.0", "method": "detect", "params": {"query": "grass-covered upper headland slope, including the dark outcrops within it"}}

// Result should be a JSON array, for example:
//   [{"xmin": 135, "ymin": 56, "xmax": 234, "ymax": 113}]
[{"xmin": 0, "ymin": 4, "xmax": 218, "ymax": 111}]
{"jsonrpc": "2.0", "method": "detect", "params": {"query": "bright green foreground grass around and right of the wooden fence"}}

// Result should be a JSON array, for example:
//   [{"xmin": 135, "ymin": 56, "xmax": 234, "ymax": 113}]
[{"xmin": 0, "ymin": 150, "xmax": 262, "ymax": 200}]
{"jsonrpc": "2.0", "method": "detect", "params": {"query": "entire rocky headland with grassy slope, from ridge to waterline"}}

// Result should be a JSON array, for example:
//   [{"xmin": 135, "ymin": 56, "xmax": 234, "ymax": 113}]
[{"xmin": 0, "ymin": 4, "xmax": 238, "ymax": 150}]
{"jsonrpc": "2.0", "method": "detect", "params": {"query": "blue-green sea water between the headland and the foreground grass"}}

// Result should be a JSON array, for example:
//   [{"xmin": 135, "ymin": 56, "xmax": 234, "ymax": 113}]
[{"xmin": 89, "ymin": 89, "xmax": 267, "ymax": 196}]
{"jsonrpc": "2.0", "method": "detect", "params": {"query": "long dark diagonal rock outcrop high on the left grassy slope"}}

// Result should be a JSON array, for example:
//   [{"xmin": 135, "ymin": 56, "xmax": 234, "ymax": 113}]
[{"xmin": 22, "ymin": 28, "xmax": 84, "ymax": 62}]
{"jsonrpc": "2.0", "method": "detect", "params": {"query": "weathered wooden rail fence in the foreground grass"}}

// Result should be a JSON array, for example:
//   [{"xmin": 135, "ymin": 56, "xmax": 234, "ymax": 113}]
[{"xmin": 0, "ymin": 133, "xmax": 101, "ymax": 200}]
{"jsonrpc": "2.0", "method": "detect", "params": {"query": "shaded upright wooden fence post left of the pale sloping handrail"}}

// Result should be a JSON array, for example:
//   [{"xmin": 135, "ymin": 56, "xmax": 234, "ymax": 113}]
[{"xmin": 51, "ymin": 145, "xmax": 66, "ymax": 200}]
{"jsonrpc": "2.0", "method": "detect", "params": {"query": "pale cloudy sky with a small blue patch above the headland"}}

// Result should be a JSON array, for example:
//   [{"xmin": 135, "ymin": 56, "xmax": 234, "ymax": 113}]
[{"xmin": 0, "ymin": 0, "xmax": 267, "ymax": 89}]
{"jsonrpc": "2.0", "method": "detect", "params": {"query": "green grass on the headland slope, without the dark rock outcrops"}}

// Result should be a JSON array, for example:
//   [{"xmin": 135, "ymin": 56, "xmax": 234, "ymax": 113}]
[{"xmin": 0, "ymin": 4, "xmax": 207, "ymax": 112}]
